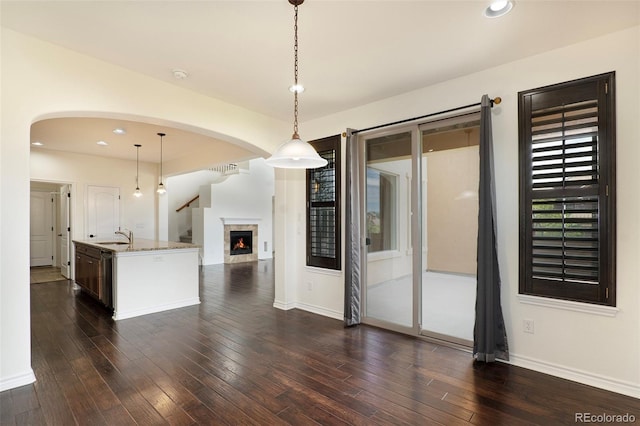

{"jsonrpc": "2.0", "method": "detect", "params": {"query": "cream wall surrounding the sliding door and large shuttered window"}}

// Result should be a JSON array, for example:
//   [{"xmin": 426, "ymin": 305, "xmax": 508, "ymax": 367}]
[{"xmin": 288, "ymin": 27, "xmax": 640, "ymax": 397}]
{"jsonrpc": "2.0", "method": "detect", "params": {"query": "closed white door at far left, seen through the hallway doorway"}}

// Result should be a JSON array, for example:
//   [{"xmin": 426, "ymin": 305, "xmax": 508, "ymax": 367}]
[{"xmin": 29, "ymin": 192, "xmax": 53, "ymax": 266}]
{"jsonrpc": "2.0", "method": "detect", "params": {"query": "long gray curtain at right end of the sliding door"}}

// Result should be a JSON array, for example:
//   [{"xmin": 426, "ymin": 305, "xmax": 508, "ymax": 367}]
[{"xmin": 473, "ymin": 95, "xmax": 509, "ymax": 362}]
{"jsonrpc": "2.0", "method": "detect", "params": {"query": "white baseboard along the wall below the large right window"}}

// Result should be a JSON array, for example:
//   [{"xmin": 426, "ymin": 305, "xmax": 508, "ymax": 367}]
[{"xmin": 508, "ymin": 353, "xmax": 640, "ymax": 398}]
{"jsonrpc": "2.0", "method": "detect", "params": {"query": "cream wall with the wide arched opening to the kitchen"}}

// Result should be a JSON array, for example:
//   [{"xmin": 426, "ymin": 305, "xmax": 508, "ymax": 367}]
[{"xmin": 0, "ymin": 28, "xmax": 289, "ymax": 390}]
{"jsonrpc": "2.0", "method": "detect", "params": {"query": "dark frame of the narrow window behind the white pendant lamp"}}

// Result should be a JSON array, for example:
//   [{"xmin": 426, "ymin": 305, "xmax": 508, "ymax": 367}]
[{"xmin": 306, "ymin": 135, "xmax": 342, "ymax": 270}]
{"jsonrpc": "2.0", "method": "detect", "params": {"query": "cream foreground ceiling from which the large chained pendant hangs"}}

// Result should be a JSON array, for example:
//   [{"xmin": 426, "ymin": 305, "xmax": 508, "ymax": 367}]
[{"xmin": 1, "ymin": 0, "xmax": 640, "ymax": 163}]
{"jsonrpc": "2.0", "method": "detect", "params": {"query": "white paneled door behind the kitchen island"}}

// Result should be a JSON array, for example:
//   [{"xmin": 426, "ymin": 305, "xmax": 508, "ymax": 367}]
[{"xmin": 86, "ymin": 185, "xmax": 120, "ymax": 240}]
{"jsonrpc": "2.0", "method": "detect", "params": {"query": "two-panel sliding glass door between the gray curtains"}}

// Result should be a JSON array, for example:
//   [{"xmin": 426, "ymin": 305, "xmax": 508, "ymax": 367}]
[{"xmin": 360, "ymin": 113, "xmax": 479, "ymax": 345}]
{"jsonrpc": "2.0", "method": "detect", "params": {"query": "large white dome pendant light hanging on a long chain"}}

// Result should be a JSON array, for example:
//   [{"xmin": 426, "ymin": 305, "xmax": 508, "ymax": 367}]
[{"xmin": 265, "ymin": 0, "xmax": 327, "ymax": 169}]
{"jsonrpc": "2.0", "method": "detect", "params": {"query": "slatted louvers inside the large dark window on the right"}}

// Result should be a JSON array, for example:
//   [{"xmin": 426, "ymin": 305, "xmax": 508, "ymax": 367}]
[{"xmin": 531, "ymin": 100, "xmax": 600, "ymax": 284}]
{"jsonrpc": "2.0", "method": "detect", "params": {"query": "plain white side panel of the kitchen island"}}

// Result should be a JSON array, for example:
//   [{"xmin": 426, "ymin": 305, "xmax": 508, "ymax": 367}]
[{"xmin": 113, "ymin": 248, "xmax": 200, "ymax": 320}]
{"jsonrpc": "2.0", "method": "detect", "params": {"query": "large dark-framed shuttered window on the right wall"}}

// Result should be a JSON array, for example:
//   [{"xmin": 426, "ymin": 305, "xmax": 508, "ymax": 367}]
[{"xmin": 518, "ymin": 72, "xmax": 616, "ymax": 306}]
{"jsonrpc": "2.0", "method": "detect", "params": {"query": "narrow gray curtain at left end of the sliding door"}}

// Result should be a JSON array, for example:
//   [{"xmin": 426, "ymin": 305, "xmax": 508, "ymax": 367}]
[{"xmin": 344, "ymin": 129, "xmax": 361, "ymax": 327}]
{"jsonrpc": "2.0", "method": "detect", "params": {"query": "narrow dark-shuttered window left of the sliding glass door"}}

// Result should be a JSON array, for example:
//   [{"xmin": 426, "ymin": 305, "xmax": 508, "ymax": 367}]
[{"xmin": 307, "ymin": 135, "xmax": 341, "ymax": 269}]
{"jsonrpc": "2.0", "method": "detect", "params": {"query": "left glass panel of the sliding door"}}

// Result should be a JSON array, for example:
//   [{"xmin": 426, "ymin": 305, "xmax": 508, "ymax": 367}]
[{"xmin": 363, "ymin": 131, "xmax": 415, "ymax": 329}]
